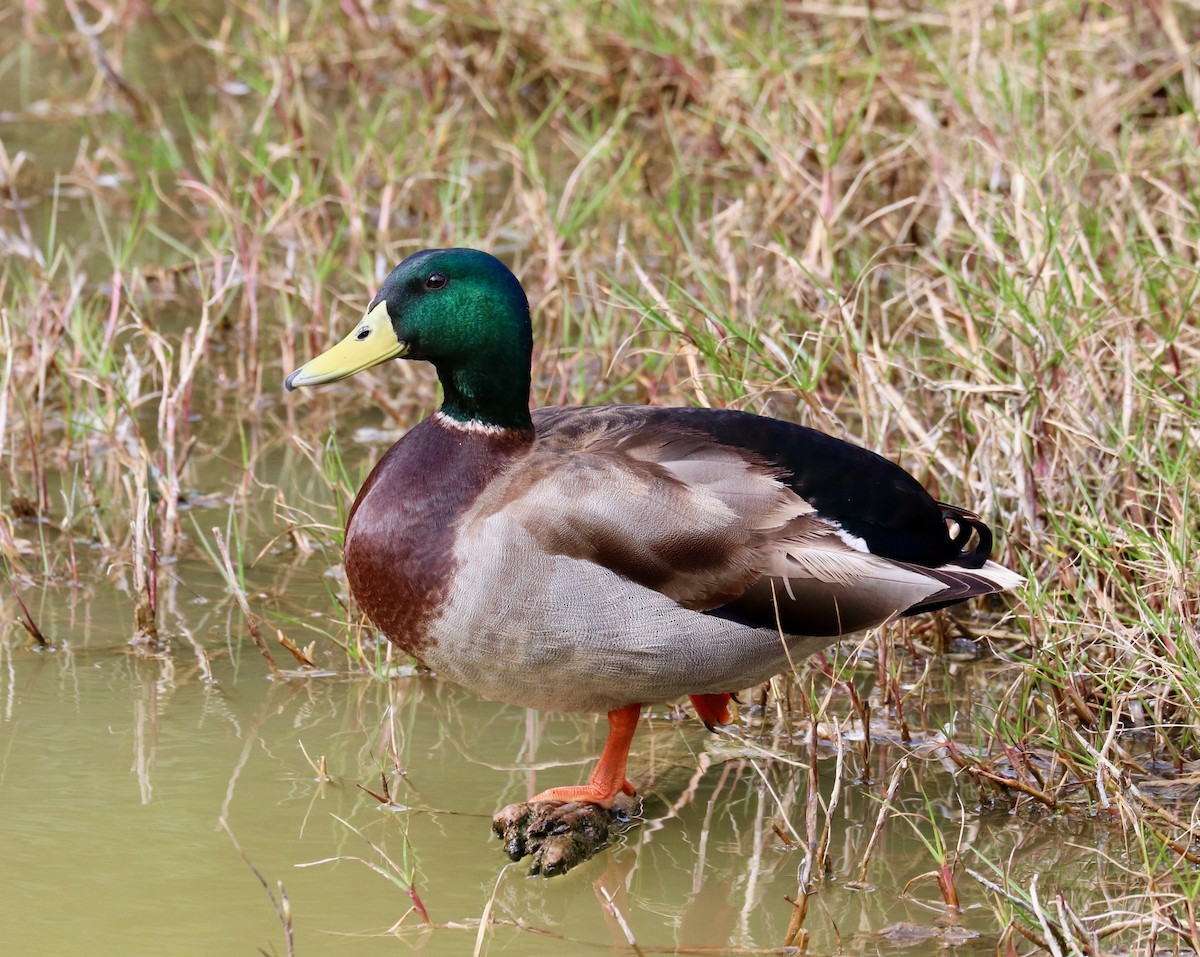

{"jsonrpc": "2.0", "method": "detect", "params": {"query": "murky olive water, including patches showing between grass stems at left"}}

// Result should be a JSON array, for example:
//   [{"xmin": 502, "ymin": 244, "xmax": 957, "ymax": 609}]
[{"xmin": 0, "ymin": 9, "xmax": 1118, "ymax": 957}]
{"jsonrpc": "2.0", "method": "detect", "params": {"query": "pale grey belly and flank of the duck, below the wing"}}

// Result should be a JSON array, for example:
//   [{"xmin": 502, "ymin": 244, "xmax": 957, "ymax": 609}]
[{"xmin": 421, "ymin": 536, "xmax": 830, "ymax": 712}]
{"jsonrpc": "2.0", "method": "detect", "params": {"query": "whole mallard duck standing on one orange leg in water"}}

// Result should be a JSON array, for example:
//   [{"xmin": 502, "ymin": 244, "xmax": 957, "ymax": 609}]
[{"xmin": 287, "ymin": 249, "xmax": 1021, "ymax": 807}]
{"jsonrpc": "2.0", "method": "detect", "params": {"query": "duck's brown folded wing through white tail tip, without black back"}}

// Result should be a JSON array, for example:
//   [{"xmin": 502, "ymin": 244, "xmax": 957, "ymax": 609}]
[{"xmin": 468, "ymin": 409, "xmax": 1019, "ymax": 636}]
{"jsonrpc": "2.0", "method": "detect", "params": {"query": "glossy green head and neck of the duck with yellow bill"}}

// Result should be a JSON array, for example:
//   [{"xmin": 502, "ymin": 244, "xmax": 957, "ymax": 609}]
[{"xmin": 284, "ymin": 249, "xmax": 533, "ymax": 428}]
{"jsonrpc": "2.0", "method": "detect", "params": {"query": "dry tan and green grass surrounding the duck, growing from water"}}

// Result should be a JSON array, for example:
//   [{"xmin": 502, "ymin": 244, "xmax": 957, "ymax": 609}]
[{"xmin": 0, "ymin": 0, "xmax": 1200, "ymax": 953}]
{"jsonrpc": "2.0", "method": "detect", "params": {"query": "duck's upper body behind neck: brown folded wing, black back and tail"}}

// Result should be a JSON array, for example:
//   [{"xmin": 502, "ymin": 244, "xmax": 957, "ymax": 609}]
[{"xmin": 470, "ymin": 407, "xmax": 1019, "ymax": 636}]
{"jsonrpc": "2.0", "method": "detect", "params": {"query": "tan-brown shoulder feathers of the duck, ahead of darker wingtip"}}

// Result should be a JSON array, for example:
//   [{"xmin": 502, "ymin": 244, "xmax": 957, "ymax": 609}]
[{"xmin": 479, "ymin": 408, "xmax": 812, "ymax": 609}]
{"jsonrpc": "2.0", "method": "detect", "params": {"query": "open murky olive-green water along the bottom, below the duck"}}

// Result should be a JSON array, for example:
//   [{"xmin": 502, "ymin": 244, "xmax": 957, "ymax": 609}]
[{"xmin": 0, "ymin": 566, "xmax": 1123, "ymax": 955}]
